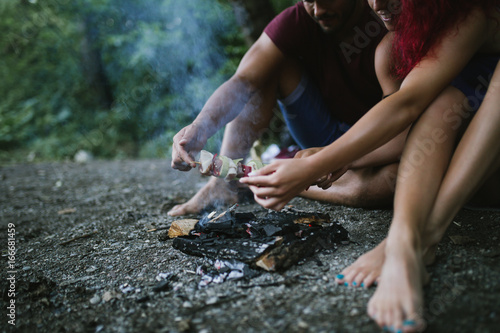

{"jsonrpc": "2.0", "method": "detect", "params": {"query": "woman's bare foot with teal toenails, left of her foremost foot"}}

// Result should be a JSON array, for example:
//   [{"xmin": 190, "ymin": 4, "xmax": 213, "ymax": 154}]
[{"xmin": 336, "ymin": 239, "xmax": 386, "ymax": 288}]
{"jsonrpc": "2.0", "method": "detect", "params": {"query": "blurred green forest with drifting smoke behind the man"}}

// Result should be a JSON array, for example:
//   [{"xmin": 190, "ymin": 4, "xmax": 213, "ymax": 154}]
[{"xmin": 0, "ymin": 0, "xmax": 296, "ymax": 163}]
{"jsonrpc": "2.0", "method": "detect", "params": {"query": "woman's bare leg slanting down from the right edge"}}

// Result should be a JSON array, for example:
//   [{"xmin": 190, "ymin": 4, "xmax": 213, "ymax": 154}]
[{"xmin": 424, "ymin": 62, "xmax": 500, "ymax": 247}]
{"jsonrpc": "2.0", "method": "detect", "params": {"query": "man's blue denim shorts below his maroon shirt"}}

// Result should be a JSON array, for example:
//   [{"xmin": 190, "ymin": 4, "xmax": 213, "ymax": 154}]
[{"xmin": 278, "ymin": 75, "xmax": 351, "ymax": 149}]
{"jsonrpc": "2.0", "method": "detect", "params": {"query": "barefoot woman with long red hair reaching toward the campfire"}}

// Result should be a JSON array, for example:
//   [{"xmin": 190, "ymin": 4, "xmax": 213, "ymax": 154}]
[{"xmin": 241, "ymin": 0, "xmax": 500, "ymax": 332}]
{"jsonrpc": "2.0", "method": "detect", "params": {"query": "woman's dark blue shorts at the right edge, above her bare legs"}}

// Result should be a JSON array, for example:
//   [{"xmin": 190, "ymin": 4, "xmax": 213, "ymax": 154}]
[{"xmin": 451, "ymin": 54, "xmax": 500, "ymax": 112}]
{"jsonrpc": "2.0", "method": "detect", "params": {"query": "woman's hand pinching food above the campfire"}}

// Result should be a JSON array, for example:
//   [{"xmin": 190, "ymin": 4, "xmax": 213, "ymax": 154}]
[{"xmin": 240, "ymin": 158, "xmax": 320, "ymax": 210}]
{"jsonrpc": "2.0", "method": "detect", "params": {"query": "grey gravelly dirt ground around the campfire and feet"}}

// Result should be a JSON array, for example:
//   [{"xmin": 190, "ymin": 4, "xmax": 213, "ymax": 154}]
[{"xmin": 0, "ymin": 160, "xmax": 500, "ymax": 333}]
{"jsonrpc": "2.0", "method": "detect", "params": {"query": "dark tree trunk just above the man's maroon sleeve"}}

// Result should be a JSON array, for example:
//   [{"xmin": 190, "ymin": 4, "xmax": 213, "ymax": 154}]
[{"xmin": 230, "ymin": 0, "xmax": 276, "ymax": 46}]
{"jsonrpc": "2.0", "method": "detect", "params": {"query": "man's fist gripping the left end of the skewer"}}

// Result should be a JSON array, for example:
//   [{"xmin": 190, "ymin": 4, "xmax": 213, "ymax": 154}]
[{"xmin": 172, "ymin": 123, "xmax": 207, "ymax": 171}]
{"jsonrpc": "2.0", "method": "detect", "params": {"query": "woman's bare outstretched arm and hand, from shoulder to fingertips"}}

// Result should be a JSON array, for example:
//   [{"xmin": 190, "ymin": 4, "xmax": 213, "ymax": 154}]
[{"xmin": 241, "ymin": 10, "xmax": 487, "ymax": 209}]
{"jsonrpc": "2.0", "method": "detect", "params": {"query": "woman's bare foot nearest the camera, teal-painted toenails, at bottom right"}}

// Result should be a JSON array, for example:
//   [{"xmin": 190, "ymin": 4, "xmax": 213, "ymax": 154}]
[{"xmin": 368, "ymin": 235, "xmax": 429, "ymax": 332}]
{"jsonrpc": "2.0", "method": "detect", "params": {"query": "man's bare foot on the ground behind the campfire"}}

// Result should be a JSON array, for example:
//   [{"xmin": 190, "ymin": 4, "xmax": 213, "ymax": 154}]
[{"xmin": 168, "ymin": 178, "xmax": 238, "ymax": 216}]
